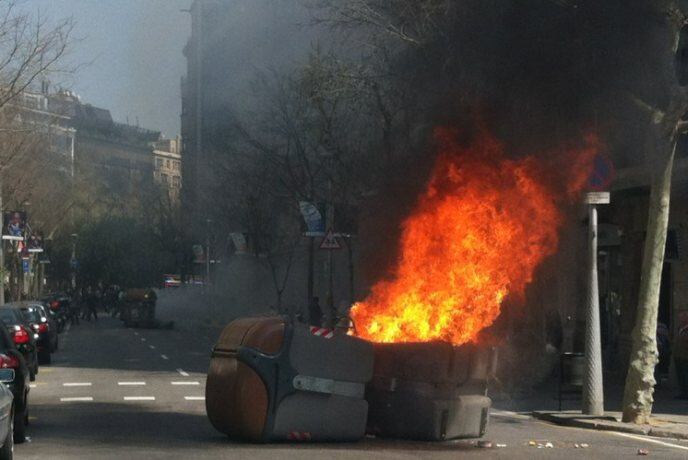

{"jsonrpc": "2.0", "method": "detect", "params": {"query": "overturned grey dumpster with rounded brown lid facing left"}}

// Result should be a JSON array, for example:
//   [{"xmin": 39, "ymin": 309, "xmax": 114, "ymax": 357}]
[{"xmin": 206, "ymin": 317, "xmax": 373, "ymax": 442}]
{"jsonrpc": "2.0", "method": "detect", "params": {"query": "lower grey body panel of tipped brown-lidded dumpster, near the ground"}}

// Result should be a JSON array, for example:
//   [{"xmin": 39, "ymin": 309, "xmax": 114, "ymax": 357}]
[{"xmin": 270, "ymin": 392, "xmax": 368, "ymax": 441}]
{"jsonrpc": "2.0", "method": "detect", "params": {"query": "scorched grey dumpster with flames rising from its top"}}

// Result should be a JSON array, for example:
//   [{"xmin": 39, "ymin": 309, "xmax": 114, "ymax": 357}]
[{"xmin": 366, "ymin": 342, "xmax": 496, "ymax": 441}]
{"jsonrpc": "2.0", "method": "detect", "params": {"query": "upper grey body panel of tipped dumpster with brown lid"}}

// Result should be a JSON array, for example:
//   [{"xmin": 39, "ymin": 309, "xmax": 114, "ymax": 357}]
[{"xmin": 289, "ymin": 325, "xmax": 374, "ymax": 383}]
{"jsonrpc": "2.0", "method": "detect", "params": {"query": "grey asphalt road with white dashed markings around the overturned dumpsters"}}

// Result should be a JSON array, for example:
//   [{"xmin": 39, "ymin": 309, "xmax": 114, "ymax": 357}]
[{"xmin": 9, "ymin": 318, "xmax": 688, "ymax": 460}]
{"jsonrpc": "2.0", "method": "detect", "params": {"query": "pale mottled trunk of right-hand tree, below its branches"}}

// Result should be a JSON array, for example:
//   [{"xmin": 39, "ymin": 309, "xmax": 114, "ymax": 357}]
[{"xmin": 623, "ymin": 135, "xmax": 676, "ymax": 424}]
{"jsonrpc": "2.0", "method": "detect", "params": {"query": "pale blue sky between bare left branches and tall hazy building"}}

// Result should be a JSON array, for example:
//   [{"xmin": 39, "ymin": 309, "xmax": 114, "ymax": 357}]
[{"xmin": 26, "ymin": 0, "xmax": 191, "ymax": 137}]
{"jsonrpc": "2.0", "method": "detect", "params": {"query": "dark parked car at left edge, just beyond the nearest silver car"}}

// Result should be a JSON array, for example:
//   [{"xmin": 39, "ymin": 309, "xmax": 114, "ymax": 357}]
[{"xmin": 0, "ymin": 323, "xmax": 31, "ymax": 446}]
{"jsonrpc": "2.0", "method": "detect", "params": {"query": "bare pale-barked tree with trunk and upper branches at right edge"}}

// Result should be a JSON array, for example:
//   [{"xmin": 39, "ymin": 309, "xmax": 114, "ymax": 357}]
[{"xmin": 623, "ymin": 0, "xmax": 688, "ymax": 423}]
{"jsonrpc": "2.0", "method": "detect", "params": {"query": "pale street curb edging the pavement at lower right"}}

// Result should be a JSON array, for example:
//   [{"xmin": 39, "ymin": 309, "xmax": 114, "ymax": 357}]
[{"xmin": 532, "ymin": 411, "xmax": 688, "ymax": 439}]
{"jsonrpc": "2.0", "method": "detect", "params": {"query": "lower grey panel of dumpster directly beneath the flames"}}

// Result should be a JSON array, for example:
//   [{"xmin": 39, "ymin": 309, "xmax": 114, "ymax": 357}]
[{"xmin": 368, "ymin": 390, "xmax": 491, "ymax": 441}]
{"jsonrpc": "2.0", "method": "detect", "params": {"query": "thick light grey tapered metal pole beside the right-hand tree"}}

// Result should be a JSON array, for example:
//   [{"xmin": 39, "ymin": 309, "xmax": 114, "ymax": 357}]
[{"xmin": 583, "ymin": 204, "xmax": 604, "ymax": 415}]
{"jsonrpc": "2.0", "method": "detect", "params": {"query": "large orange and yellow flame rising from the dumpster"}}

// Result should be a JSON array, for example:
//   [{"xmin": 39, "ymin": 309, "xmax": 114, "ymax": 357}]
[{"xmin": 351, "ymin": 129, "xmax": 597, "ymax": 345}]
